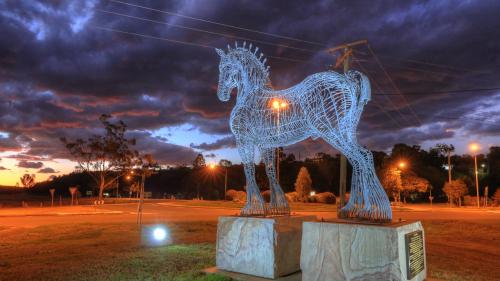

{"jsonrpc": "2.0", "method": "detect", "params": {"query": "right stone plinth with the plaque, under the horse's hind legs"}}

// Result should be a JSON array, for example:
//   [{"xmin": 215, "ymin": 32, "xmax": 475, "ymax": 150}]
[{"xmin": 300, "ymin": 220, "xmax": 427, "ymax": 281}]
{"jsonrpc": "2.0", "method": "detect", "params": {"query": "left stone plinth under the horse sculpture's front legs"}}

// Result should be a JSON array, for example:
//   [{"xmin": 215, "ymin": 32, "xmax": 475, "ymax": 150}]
[{"xmin": 216, "ymin": 216, "xmax": 316, "ymax": 279}]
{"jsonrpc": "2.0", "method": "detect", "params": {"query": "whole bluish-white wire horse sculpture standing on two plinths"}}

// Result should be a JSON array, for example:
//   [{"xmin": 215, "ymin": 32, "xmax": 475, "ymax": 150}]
[{"xmin": 216, "ymin": 43, "xmax": 392, "ymax": 221}]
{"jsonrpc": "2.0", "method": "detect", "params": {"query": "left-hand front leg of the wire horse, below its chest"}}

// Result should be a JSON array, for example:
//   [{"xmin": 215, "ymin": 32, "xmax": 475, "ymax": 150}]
[{"xmin": 238, "ymin": 141, "xmax": 265, "ymax": 216}]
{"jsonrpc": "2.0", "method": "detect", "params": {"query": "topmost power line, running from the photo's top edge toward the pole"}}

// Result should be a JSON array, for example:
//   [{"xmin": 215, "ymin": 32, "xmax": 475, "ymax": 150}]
[{"xmin": 109, "ymin": 0, "xmax": 326, "ymax": 47}]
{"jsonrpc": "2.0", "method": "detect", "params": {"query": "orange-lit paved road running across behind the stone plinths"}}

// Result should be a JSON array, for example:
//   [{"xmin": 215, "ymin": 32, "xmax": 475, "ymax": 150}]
[{"xmin": 0, "ymin": 200, "xmax": 500, "ymax": 227}]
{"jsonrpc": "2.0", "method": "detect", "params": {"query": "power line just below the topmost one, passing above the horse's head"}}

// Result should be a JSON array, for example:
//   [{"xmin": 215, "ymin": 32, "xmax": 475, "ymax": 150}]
[{"xmin": 96, "ymin": 9, "xmax": 316, "ymax": 53}]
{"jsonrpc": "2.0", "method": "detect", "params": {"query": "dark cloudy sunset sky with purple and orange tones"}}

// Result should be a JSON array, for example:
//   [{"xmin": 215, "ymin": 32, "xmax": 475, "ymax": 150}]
[{"xmin": 0, "ymin": 0, "xmax": 500, "ymax": 185}]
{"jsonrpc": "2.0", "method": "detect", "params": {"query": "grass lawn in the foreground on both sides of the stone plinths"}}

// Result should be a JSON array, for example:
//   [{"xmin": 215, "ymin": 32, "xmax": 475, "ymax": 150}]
[{"xmin": 0, "ymin": 217, "xmax": 500, "ymax": 281}]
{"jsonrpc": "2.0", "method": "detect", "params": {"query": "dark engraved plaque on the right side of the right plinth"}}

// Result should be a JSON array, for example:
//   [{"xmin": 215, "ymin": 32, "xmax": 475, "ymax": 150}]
[{"xmin": 405, "ymin": 230, "xmax": 425, "ymax": 280}]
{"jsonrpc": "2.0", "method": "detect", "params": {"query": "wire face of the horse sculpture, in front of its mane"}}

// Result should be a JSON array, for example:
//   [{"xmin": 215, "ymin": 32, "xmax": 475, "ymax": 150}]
[{"xmin": 215, "ymin": 49, "xmax": 238, "ymax": 101}]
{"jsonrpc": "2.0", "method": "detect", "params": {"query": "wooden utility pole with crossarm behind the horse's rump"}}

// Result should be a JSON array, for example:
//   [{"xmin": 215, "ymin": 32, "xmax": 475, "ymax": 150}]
[{"xmin": 327, "ymin": 40, "xmax": 368, "ymax": 218}]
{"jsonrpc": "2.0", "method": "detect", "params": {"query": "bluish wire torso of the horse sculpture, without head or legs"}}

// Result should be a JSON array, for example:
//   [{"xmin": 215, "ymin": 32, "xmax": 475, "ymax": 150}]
[{"xmin": 230, "ymin": 71, "xmax": 362, "ymax": 148}]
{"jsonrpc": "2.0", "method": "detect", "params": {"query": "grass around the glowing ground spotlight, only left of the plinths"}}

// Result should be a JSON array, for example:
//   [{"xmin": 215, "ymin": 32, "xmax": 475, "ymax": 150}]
[{"xmin": 0, "ymin": 222, "xmax": 228, "ymax": 281}]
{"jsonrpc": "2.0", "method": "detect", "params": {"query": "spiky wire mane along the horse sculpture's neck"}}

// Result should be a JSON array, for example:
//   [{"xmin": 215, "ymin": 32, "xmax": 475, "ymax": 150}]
[{"xmin": 227, "ymin": 42, "xmax": 271, "ymax": 86}]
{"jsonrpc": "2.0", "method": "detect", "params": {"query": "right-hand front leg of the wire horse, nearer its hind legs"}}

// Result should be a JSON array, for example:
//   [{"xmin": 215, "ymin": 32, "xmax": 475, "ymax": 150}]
[{"xmin": 260, "ymin": 148, "xmax": 290, "ymax": 215}]
